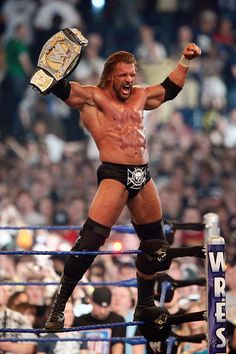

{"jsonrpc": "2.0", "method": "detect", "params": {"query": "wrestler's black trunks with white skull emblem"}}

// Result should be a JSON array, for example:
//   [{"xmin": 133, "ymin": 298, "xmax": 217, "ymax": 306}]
[{"xmin": 97, "ymin": 162, "xmax": 151, "ymax": 198}]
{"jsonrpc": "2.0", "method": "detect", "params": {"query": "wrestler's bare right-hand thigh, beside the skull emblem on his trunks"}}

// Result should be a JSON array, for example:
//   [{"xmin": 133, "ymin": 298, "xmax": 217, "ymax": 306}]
[{"xmin": 127, "ymin": 179, "xmax": 162, "ymax": 225}]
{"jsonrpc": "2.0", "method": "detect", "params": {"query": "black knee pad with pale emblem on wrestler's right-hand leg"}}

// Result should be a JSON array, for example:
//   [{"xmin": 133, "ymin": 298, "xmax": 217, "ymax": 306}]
[{"xmin": 136, "ymin": 239, "xmax": 171, "ymax": 275}]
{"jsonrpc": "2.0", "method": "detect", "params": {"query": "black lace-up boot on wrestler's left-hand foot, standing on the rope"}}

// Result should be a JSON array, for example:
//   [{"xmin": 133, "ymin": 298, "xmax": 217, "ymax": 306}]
[{"xmin": 45, "ymin": 276, "xmax": 77, "ymax": 332}]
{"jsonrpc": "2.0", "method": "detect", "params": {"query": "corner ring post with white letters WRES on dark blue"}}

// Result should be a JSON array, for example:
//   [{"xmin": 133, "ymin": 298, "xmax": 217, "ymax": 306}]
[{"xmin": 204, "ymin": 213, "xmax": 226, "ymax": 354}]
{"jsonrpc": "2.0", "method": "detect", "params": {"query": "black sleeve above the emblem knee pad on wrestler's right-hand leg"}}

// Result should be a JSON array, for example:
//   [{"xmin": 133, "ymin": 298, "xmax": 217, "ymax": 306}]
[{"xmin": 132, "ymin": 219, "xmax": 165, "ymax": 241}]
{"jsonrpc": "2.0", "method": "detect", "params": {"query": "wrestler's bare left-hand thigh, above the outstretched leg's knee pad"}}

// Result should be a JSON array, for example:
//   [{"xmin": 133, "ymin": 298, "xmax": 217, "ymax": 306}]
[{"xmin": 88, "ymin": 179, "xmax": 128, "ymax": 227}]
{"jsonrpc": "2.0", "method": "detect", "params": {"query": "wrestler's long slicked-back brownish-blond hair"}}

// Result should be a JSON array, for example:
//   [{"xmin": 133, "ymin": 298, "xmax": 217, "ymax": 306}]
[{"xmin": 97, "ymin": 51, "xmax": 137, "ymax": 88}]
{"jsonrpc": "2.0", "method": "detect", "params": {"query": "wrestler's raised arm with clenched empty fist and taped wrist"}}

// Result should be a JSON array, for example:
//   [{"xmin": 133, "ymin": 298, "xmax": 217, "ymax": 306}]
[{"xmin": 145, "ymin": 43, "xmax": 201, "ymax": 110}]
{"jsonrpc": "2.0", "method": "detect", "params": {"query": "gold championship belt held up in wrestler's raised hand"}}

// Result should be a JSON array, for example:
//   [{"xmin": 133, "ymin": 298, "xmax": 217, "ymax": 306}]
[{"xmin": 30, "ymin": 28, "xmax": 88, "ymax": 94}]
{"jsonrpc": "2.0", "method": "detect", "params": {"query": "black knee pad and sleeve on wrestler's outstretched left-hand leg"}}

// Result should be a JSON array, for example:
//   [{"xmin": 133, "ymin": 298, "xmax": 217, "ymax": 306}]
[{"xmin": 64, "ymin": 218, "xmax": 111, "ymax": 282}]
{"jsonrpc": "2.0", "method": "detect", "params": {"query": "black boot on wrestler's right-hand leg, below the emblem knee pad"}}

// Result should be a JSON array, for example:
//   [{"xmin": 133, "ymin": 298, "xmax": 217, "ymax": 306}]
[{"xmin": 134, "ymin": 275, "xmax": 155, "ymax": 321}]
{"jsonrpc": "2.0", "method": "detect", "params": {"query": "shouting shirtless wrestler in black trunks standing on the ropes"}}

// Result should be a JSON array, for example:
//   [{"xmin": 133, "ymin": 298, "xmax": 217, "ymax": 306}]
[{"xmin": 32, "ymin": 37, "xmax": 201, "ymax": 331}]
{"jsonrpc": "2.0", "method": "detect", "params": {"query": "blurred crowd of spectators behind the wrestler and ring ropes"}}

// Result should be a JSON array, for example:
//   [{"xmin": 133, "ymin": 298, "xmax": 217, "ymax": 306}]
[{"xmin": 0, "ymin": 0, "xmax": 236, "ymax": 354}]
